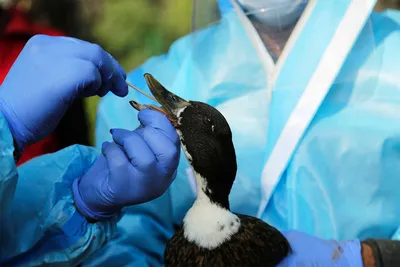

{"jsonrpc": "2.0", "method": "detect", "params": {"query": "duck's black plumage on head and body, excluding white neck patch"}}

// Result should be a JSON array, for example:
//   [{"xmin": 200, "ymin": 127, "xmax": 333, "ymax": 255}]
[{"xmin": 164, "ymin": 101, "xmax": 290, "ymax": 267}]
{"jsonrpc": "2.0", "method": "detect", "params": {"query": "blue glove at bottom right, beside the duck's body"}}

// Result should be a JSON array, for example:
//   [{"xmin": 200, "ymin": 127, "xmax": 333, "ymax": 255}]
[{"xmin": 278, "ymin": 231, "xmax": 363, "ymax": 267}]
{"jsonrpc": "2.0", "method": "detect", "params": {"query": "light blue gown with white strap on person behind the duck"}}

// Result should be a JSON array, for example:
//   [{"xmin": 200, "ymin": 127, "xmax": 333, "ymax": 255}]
[{"xmin": 85, "ymin": 0, "xmax": 400, "ymax": 266}]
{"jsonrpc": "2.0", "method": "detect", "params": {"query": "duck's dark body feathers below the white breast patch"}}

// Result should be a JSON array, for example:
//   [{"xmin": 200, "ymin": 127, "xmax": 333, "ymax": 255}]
[{"xmin": 164, "ymin": 214, "xmax": 290, "ymax": 267}]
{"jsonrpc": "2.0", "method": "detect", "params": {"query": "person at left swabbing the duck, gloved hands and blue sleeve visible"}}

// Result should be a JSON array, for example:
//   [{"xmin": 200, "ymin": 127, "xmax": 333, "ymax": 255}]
[{"xmin": 0, "ymin": 34, "xmax": 180, "ymax": 266}]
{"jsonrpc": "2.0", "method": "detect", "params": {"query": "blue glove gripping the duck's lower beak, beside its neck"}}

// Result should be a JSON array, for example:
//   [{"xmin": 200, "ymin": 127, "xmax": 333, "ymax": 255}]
[{"xmin": 73, "ymin": 109, "xmax": 180, "ymax": 220}]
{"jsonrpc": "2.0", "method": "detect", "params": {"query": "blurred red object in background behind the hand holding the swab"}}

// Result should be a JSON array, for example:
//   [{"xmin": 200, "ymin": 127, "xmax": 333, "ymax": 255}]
[{"xmin": 0, "ymin": 9, "xmax": 64, "ymax": 166}]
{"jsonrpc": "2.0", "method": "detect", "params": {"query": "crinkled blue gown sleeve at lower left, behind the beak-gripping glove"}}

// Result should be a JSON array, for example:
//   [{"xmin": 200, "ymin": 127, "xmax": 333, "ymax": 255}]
[{"xmin": 0, "ymin": 114, "xmax": 119, "ymax": 266}]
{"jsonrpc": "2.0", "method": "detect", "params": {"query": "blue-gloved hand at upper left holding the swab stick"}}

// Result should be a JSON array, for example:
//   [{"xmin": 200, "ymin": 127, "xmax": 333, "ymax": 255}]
[{"xmin": 0, "ymin": 35, "xmax": 128, "ymax": 151}]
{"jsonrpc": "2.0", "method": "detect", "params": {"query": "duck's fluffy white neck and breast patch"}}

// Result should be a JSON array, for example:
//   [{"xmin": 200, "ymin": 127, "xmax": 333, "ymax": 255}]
[{"xmin": 183, "ymin": 173, "xmax": 240, "ymax": 249}]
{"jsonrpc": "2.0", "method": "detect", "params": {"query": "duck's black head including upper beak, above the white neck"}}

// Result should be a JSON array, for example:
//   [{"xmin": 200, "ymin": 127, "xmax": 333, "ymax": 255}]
[{"xmin": 139, "ymin": 74, "xmax": 237, "ymax": 209}]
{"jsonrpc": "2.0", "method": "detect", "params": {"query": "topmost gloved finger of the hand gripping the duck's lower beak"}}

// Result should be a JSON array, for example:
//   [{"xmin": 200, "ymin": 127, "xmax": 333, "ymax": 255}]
[{"xmin": 138, "ymin": 109, "xmax": 179, "ymax": 145}]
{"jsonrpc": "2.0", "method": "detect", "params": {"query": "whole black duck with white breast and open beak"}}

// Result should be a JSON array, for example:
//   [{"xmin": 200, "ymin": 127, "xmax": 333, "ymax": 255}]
[{"xmin": 130, "ymin": 73, "xmax": 291, "ymax": 267}]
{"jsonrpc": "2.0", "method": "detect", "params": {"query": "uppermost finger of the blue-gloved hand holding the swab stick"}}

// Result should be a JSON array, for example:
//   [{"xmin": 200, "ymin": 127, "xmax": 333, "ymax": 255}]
[{"xmin": 41, "ymin": 37, "xmax": 128, "ymax": 97}]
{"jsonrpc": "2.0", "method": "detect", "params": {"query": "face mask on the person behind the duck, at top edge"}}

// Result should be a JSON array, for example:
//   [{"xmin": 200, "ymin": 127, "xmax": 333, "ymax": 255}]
[{"xmin": 237, "ymin": 0, "xmax": 308, "ymax": 28}]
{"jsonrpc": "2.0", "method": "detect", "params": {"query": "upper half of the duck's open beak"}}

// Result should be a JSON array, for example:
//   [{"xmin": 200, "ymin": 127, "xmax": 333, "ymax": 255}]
[{"xmin": 144, "ymin": 73, "xmax": 190, "ymax": 119}]
